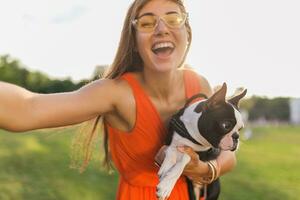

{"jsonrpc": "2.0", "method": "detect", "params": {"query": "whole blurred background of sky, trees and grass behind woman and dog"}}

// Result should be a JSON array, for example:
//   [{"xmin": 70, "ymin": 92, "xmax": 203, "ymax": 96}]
[{"xmin": 0, "ymin": 0, "xmax": 300, "ymax": 200}]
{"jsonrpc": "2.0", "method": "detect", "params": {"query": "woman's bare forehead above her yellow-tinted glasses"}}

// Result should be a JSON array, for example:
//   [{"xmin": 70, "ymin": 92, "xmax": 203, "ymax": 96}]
[{"xmin": 138, "ymin": 0, "xmax": 181, "ymax": 16}]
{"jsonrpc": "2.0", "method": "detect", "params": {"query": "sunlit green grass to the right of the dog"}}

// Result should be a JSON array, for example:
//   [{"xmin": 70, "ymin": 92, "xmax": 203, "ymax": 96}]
[{"xmin": 220, "ymin": 126, "xmax": 300, "ymax": 200}]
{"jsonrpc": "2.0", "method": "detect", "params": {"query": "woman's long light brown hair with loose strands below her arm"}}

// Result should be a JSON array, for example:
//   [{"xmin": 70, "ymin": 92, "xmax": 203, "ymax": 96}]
[{"xmin": 70, "ymin": 0, "xmax": 192, "ymax": 171}]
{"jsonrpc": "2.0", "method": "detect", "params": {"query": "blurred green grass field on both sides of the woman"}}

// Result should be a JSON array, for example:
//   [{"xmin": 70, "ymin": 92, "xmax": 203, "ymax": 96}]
[{"xmin": 0, "ymin": 126, "xmax": 300, "ymax": 200}]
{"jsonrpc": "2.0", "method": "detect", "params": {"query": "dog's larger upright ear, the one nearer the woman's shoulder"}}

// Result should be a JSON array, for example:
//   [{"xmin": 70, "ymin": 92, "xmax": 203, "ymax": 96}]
[{"xmin": 195, "ymin": 83, "xmax": 227, "ymax": 113}]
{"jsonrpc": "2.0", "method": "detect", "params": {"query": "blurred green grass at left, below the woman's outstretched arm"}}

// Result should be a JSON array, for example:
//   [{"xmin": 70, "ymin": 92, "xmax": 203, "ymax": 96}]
[{"xmin": 0, "ymin": 129, "xmax": 117, "ymax": 200}]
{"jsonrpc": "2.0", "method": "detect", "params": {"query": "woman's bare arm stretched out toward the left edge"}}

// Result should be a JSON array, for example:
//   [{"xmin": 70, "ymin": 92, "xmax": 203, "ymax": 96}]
[{"xmin": 0, "ymin": 80, "xmax": 116, "ymax": 132}]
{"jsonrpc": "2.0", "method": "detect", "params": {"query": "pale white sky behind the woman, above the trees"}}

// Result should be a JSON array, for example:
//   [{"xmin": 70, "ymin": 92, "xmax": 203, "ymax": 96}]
[{"xmin": 0, "ymin": 0, "xmax": 300, "ymax": 97}]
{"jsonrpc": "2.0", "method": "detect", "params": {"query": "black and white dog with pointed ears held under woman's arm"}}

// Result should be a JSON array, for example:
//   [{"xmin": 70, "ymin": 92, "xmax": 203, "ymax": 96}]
[{"xmin": 157, "ymin": 83, "xmax": 247, "ymax": 200}]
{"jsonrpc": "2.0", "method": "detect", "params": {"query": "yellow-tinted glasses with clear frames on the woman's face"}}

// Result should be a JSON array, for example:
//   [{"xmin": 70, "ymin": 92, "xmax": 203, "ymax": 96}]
[{"xmin": 132, "ymin": 13, "xmax": 187, "ymax": 32}]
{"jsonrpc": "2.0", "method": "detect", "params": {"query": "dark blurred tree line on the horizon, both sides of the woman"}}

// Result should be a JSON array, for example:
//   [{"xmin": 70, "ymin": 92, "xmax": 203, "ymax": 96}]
[{"xmin": 0, "ymin": 55, "xmax": 290, "ymax": 122}]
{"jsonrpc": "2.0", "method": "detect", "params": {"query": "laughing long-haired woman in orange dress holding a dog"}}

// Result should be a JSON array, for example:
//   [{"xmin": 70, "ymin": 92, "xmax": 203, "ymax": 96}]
[{"xmin": 0, "ymin": 0, "xmax": 235, "ymax": 200}]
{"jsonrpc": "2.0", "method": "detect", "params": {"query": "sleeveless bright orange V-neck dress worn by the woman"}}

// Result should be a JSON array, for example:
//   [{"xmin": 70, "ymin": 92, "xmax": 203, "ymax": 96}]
[{"xmin": 106, "ymin": 70, "xmax": 200, "ymax": 200}]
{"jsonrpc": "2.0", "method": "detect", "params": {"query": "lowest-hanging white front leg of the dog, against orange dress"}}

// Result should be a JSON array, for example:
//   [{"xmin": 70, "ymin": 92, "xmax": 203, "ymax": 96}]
[{"xmin": 157, "ymin": 151, "xmax": 191, "ymax": 198}]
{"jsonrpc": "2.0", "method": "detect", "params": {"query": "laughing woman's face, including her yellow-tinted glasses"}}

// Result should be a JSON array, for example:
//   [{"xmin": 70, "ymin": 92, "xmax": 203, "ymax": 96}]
[{"xmin": 134, "ymin": 1, "xmax": 191, "ymax": 71}]
